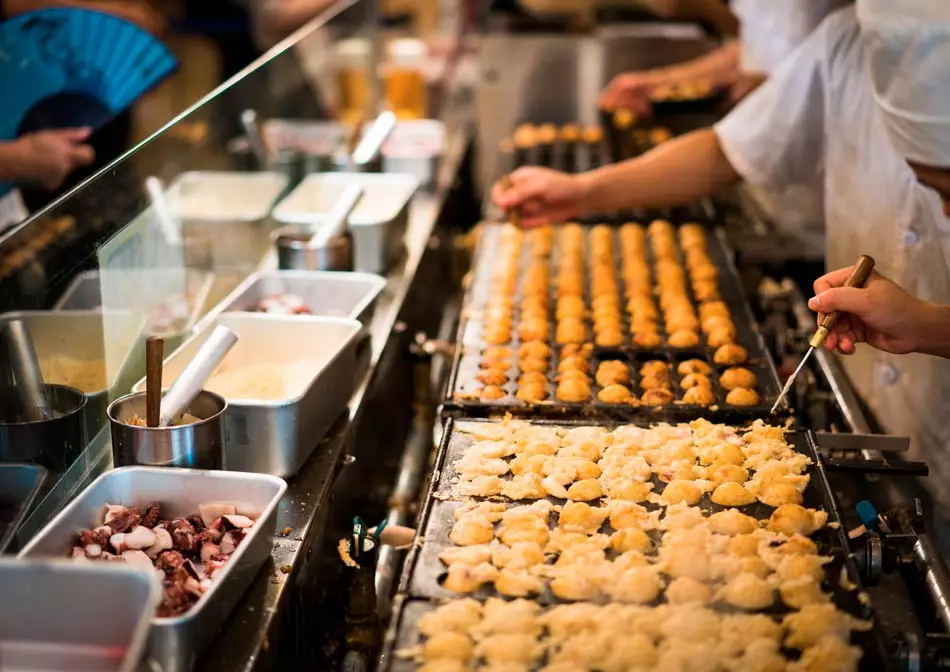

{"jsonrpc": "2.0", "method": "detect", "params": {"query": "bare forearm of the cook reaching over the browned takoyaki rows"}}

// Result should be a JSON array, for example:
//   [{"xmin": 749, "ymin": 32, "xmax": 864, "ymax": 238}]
[{"xmin": 581, "ymin": 129, "xmax": 739, "ymax": 212}]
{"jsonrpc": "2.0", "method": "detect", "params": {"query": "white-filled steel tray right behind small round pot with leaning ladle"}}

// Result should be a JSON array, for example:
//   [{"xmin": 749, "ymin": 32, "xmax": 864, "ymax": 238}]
[{"xmin": 274, "ymin": 173, "xmax": 419, "ymax": 273}]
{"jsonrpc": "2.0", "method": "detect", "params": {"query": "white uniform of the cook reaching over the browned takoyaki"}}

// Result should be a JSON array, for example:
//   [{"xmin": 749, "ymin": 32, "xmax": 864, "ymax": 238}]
[{"xmin": 715, "ymin": 2, "xmax": 950, "ymax": 506}]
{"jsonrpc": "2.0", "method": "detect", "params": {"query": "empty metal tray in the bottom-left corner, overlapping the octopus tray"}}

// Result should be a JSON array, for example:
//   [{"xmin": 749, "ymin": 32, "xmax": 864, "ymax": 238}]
[{"xmin": 0, "ymin": 560, "xmax": 160, "ymax": 672}]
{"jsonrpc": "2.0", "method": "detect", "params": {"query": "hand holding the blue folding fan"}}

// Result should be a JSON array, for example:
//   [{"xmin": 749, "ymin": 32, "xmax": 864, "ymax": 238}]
[{"xmin": 14, "ymin": 128, "xmax": 95, "ymax": 191}]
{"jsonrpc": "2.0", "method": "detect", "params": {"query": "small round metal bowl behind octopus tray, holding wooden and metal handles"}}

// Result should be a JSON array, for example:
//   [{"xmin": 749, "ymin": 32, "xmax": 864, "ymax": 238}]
[{"xmin": 108, "ymin": 391, "xmax": 228, "ymax": 469}]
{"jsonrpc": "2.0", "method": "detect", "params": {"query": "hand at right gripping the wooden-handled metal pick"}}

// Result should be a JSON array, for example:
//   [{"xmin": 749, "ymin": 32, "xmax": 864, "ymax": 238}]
[{"xmin": 808, "ymin": 266, "xmax": 936, "ymax": 355}]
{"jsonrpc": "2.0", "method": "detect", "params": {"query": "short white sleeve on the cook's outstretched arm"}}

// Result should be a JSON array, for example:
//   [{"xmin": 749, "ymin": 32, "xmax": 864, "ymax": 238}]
[{"xmin": 714, "ymin": 16, "xmax": 829, "ymax": 186}]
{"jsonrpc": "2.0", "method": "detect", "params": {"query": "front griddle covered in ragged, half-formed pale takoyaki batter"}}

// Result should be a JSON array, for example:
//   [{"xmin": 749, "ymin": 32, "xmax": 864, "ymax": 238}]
[{"xmin": 384, "ymin": 422, "xmax": 883, "ymax": 670}]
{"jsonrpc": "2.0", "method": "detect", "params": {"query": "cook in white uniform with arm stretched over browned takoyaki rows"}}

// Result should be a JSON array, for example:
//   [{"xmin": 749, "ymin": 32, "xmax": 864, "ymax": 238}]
[{"xmin": 493, "ymin": 0, "xmax": 950, "ymax": 524}]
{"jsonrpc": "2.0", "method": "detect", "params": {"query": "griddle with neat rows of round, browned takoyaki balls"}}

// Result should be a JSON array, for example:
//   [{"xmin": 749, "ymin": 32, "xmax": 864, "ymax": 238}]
[{"xmin": 446, "ymin": 225, "xmax": 779, "ymax": 421}]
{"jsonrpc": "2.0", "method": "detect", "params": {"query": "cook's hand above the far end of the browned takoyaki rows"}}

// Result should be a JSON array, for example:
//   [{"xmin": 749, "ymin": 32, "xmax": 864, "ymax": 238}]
[{"xmin": 492, "ymin": 166, "xmax": 587, "ymax": 228}]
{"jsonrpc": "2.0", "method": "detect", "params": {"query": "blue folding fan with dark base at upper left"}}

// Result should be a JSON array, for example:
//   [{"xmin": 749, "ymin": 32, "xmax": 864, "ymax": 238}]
[{"xmin": 0, "ymin": 9, "xmax": 178, "ymax": 195}]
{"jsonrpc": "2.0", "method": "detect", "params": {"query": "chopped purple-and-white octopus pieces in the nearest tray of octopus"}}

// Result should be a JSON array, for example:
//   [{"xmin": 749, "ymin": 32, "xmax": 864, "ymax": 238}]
[{"xmin": 72, "ymin": 502, "xmax": 255, "ymax": 617}]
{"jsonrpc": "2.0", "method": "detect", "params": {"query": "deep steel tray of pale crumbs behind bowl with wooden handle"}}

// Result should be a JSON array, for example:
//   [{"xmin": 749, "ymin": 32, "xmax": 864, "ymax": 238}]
[{"xmin": 135, "ymin": 313, "xmax": 362, "ymax": 477}]
